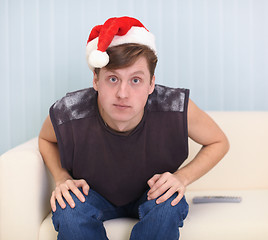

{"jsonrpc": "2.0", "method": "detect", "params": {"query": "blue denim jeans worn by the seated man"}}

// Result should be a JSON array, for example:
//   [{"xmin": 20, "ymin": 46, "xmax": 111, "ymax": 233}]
[{"xmin": 52, "ymin": 189, "xmax": 189, "ymax": 240}]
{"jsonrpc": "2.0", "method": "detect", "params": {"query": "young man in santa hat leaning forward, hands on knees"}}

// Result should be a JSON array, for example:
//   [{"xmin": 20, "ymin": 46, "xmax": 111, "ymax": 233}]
[{"xmin": 39, "ymin": 17, "xmax": 229, "ymax": 240}]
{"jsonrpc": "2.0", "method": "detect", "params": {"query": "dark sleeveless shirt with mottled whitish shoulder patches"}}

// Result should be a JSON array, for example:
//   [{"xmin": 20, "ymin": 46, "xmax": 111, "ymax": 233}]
[{"xmin": 50, "ymin": 85, "xmax": 189, "ymax": 206}]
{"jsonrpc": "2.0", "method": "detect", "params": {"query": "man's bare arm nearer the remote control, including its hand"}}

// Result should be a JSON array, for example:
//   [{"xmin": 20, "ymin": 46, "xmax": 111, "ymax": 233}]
[{"xmin": 148, "ymin": 100, "xmax": 229, "ymax": 205}]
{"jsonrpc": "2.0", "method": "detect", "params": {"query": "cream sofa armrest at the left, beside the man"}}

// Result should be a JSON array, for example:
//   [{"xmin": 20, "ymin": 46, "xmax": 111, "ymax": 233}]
[{"xmin": 0, "ymin": 138, "xmax": 53, "ymax": 240}]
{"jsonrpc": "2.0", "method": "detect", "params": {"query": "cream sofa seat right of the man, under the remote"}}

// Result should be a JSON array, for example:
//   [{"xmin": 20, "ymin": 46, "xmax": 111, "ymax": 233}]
[{"xmin": 181, "ymin": 190, "xmax": 268, "ymax": 240}]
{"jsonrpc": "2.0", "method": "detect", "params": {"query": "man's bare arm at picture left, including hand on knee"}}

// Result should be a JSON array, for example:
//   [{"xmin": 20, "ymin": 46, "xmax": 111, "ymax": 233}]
[{"xmin": 39, "ymin": 116, "xmax": 89, "ymax": 212}]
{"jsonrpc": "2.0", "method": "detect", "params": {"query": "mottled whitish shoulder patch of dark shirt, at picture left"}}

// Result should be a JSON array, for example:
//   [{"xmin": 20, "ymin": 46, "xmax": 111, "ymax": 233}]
[{"xmin": 50, "ymin": 88, "xmax": 97, "ymax": 124}]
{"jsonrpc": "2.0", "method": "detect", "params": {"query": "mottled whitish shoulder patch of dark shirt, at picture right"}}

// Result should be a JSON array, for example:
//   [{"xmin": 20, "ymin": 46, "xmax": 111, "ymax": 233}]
[{"xmin": 148, "ymin": 85, "xmax": 189, "ymax": 112}]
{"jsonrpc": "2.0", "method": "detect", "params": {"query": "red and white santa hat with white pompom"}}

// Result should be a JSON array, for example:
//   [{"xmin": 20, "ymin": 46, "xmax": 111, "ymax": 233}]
[{"xmin": 86, "ymin": 17, "xmax": 156, "ymax": 71}]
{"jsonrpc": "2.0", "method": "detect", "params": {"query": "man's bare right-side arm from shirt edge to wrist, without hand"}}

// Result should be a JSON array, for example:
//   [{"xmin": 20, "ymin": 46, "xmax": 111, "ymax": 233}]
[{"xmin": 177, "ymin": 101, "xmax": 230, "ymax": 186}]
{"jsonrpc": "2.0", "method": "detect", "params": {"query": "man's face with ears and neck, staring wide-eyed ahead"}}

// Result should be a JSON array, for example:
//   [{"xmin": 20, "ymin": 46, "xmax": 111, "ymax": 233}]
[{"xmin": 93, "ymin": 57, "xmax": 155, "ymax": 131}]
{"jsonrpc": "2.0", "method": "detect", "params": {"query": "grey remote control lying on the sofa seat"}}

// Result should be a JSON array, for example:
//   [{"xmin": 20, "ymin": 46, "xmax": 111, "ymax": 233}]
[{"xmin": 193, "ymin": 196, "xmax": 242, "ymax": 203}]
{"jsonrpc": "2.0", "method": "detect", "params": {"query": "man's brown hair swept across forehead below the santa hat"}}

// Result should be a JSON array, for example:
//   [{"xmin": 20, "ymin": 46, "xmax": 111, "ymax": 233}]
[{"xmin": 94, "ymin": 43, "xmax": 157, "ymax": 79}]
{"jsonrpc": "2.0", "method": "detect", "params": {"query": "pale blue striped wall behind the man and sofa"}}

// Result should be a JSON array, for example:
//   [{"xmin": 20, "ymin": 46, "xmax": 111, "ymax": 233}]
[{"xmin": 0, "ymin": 0, "xmax": 268, "ymax": 154}]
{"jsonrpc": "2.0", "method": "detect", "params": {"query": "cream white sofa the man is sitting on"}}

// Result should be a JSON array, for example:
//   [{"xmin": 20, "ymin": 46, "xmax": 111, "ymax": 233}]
[{"xmin": 0, "ymin": 112, "xmax": 268, "ymax": 240}]
